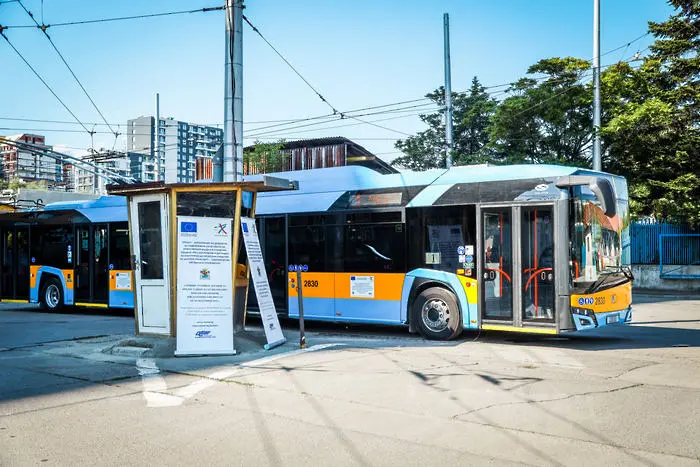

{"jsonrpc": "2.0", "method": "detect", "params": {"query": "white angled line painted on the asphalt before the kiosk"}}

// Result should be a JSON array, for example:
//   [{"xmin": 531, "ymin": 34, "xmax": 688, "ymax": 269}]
[{"xmin": 136, "ymin": 344, "xmax": 342, "ymax": 407}]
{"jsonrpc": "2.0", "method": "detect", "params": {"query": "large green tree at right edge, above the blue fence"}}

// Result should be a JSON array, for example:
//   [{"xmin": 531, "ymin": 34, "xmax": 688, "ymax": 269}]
[{"xmin": 602, "ymin": 0, "xmax": 700, "ymax": 224}]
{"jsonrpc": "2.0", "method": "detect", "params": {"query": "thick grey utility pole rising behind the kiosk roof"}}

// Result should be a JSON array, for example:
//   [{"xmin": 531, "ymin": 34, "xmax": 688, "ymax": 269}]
[{"xmin": 227, "ymin": 0, "xmax": 243, "ymax": 182}]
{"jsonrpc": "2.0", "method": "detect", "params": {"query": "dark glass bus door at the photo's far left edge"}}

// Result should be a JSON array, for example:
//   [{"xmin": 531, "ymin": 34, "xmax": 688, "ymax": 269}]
[{"xmin": 0, "ymin": 226, "xmax": 30, "ymax": 302}]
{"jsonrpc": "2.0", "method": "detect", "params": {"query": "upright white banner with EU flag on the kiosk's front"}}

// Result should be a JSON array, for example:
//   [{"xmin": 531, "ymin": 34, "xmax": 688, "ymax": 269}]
[{"xmin": 175, "ymin": 216, "xmax": 236, "ymax": 355}]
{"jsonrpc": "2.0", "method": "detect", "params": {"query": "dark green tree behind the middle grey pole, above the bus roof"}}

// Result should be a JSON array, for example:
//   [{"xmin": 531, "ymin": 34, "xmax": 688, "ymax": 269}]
[{"xmin": 392, "ymin": 77, "xmax": 498, "ymax": 170}]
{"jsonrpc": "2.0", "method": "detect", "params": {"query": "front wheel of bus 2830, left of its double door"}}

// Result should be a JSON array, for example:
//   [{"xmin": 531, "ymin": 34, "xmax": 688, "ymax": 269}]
[{"xmin": 413, "ymin": 287, "xmax": 462, "ymax": 340}]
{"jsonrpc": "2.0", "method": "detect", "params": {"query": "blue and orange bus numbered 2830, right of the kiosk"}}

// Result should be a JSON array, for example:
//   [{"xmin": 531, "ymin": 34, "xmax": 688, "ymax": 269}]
[{"xmin": 247, "ymin": 165, "xmax": 632, "ymax": 339}]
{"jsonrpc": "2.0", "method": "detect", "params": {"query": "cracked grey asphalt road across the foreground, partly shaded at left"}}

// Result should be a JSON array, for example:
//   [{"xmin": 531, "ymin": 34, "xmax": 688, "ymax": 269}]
[{"xmin": 0, "ymin": 295, "xmax": 700, "ymax": 466}]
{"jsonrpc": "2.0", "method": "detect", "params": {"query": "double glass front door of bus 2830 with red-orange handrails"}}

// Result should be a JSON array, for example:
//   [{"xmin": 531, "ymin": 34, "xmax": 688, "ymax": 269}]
[{"xmin": 479, "ymin": 204, "xmax": 557, "ymax": 334}]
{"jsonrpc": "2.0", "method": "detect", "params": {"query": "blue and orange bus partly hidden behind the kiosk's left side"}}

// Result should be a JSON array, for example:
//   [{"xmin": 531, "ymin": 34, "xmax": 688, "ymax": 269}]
[{"xmin": 0, "ymin": 197, "xmax": 134, "ymax": 310}]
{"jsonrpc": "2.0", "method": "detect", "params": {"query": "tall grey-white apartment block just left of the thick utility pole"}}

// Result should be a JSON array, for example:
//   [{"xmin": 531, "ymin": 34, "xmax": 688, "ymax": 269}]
[{"xmin": 126, "ymin": 117, "xmax": 224, "ymax": 183}]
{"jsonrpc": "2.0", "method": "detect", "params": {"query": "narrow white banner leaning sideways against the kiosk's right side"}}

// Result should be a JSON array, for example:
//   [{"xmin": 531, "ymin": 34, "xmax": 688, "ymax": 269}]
[{"xmin": 241, "ymin": 217, "xmax": 287, "ymax": 349}]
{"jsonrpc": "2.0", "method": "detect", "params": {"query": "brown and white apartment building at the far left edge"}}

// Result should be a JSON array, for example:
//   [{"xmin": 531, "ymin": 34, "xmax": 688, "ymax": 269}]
[{"xmin": 0, "ymin": 133, "xmax": 63, "ymax": 187}]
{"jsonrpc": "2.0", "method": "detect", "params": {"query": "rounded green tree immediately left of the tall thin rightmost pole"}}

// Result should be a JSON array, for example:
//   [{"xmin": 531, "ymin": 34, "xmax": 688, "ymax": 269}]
[{"xmin": 489, "ymin": 57, "xmax": 592, "ymax": 167}]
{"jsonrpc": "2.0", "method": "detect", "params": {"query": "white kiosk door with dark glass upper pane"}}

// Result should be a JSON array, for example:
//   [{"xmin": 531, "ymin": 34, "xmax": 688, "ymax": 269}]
[{"xmin": 130, "ymin": 194, "xmax": 170, "ymax": 335}]
